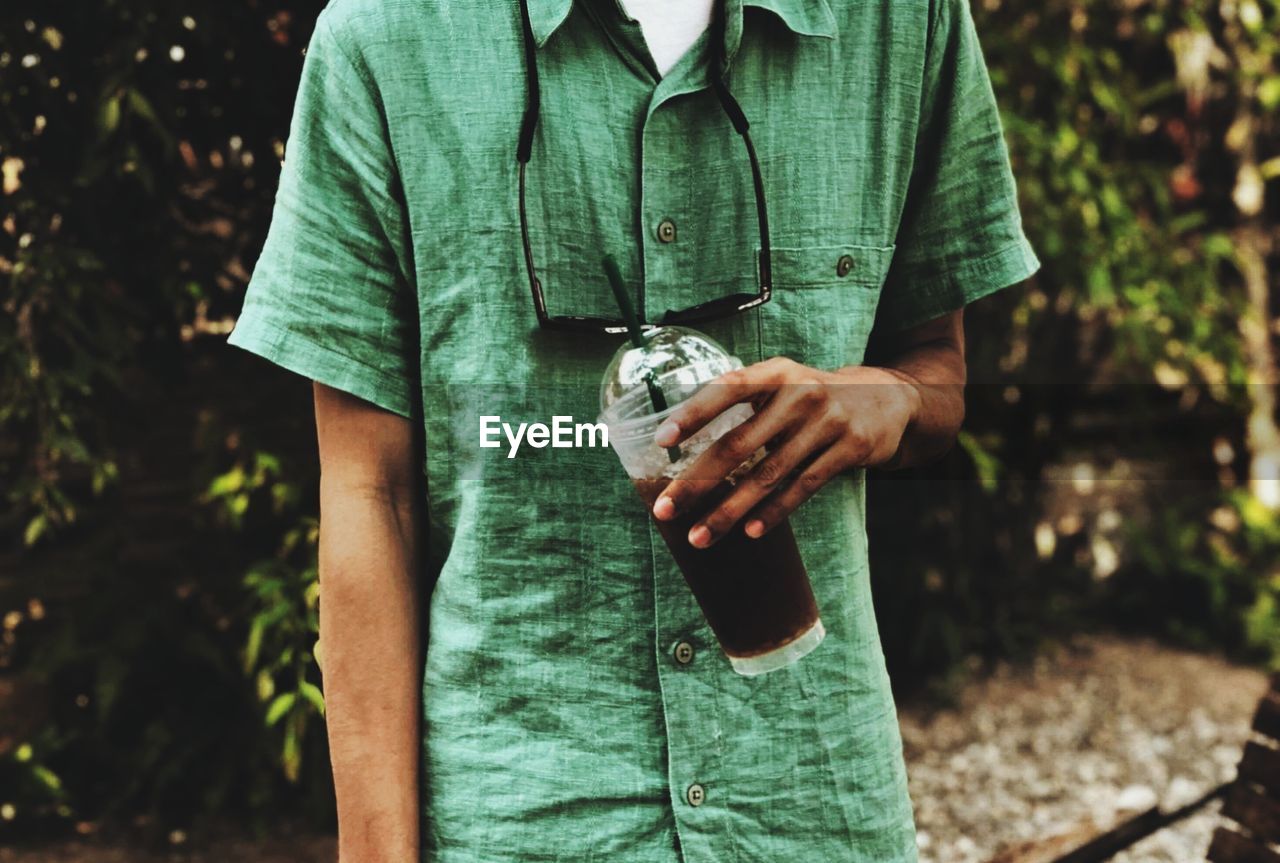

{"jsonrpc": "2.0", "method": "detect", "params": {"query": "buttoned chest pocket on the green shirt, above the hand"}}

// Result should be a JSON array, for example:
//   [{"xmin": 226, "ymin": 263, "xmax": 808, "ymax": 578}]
[{"xmin": 760, "ymin": 245, "xmax": 893, "ymax": 370}]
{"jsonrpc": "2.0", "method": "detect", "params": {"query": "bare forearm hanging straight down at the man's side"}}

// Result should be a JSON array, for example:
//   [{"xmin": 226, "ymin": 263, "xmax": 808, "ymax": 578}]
[{"xmin": 320, "ymin": 479, "xmax": 421, "ymax": 863}]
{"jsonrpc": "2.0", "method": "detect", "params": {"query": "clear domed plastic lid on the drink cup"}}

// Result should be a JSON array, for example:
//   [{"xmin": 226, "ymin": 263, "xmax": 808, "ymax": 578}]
[{"xmin": 600, "ymin": 327, "xmax": 742, "ymax": 414}]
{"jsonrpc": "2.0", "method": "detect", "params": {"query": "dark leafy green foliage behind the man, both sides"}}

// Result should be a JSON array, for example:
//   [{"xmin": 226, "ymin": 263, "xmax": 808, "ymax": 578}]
[{"xmin": 0, "ymin": 0, "xmax": 1280, "ymax": 835}]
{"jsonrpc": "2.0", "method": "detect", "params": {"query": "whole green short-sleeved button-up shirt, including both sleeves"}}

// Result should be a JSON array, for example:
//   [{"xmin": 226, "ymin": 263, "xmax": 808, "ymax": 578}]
[{"xmin": 230, "ymin": 0, "xmax": 1037, "ymax": 863}]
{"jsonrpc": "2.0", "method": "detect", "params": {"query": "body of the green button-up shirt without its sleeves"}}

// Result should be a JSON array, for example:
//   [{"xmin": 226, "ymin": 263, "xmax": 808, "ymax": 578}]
[{"xmin": 318, "ymin": 0, "xmax": 929, "ymax": 863}]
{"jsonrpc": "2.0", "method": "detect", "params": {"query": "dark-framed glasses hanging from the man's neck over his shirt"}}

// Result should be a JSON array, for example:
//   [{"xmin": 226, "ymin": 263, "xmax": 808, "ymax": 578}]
[{"xmin": 516, "ymin": 0, "xmax": 773, "ymax": 334}]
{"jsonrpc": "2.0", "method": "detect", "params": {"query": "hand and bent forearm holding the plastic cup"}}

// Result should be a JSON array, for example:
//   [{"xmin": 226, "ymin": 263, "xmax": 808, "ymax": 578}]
[{"xmin": 653, "ymin": 312, "xmax": 965, "ymax": 548}]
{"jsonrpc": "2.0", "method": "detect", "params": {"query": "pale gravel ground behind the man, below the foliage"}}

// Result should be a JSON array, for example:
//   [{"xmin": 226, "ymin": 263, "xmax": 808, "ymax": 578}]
[{"xmin": 0, "ymin": 638, "xmax": 1266, "ymax": 863}]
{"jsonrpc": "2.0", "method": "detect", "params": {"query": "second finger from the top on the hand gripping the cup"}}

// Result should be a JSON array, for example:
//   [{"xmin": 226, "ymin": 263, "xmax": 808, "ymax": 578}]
[{"xmin": 653, "ymin": 387, "xmax": 805, "ymax": 524}]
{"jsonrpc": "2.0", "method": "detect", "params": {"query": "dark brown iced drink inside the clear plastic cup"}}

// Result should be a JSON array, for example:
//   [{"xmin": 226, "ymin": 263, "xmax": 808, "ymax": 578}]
[{"xmin": 636, "ymin": 479, "xmax": 818, "ymax": 659}]
